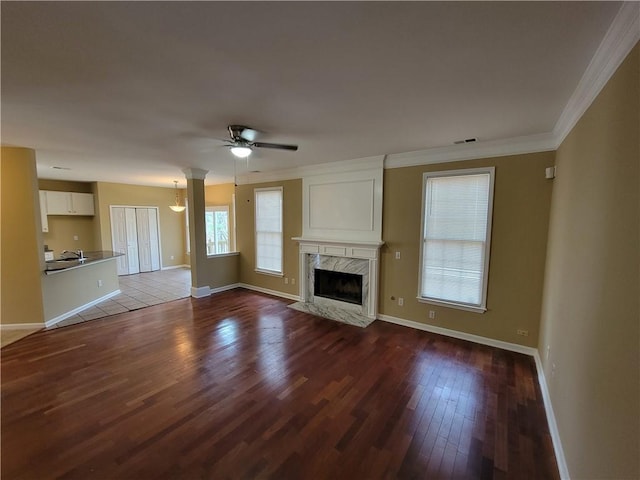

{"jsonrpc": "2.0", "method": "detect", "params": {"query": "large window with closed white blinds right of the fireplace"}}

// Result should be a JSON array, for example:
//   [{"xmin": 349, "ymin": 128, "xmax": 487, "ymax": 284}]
[{"xmin": 418, "ymin": 167, "xmax": 495, "ymax": 312}]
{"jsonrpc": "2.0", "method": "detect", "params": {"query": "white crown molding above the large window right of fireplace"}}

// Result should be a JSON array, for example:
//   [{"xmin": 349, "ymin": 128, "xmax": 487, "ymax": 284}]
[{"xmin": 384, "ymin": 133, "xmax": 555, "ymax": 168}]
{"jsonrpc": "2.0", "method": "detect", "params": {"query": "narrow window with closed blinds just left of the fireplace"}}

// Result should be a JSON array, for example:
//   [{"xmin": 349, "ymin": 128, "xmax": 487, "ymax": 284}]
[{"xmin": 254, "ymin": 187, "xmax": 282, "ymax": 274}]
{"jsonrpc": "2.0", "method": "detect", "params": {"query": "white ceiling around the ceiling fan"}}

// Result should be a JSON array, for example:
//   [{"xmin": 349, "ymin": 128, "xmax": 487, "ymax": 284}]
[{"xmin": 1, "ymin": 1, "xmax": 621, "ymax": 187}]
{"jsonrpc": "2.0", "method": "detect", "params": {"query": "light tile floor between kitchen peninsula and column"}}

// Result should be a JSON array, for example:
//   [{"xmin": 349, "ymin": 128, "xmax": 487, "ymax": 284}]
[{"xmin": 50, "ymin": 268, "xmax": 191, "ymax": 328}]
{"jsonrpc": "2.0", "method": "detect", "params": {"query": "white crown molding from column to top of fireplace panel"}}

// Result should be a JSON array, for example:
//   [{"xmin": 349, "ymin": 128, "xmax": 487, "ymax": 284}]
[{"xmin": 236, "ymin": 155, "xmax": 385, "ymax": 185}]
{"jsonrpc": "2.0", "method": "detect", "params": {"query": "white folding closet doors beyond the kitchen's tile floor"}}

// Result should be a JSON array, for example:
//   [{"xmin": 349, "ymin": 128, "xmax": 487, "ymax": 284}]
[{"xmin": 111, "ymin": 205, "xmax": 161, "ymax": 275}]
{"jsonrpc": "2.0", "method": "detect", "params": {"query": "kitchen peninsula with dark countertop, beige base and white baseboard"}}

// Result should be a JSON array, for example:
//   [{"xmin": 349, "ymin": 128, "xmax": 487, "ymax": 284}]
[{"xmin": 42, "ymin": 251, "xmax": 122, "ymax": 327}]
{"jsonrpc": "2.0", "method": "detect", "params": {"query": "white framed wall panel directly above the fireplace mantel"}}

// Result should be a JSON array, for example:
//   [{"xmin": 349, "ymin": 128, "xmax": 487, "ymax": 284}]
[{"xmin": 302, "ymin": 157, "xmax": 384, "ymax": 243}]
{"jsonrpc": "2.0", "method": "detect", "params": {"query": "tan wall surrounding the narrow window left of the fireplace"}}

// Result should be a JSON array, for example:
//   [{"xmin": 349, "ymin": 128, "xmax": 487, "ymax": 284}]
[{"xmin": 236, "ymin": 179, "xmax": 302, "ymax": 295}]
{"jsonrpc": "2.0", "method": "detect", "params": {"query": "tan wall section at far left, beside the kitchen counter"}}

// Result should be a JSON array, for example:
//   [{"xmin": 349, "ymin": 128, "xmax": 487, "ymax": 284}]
[{"xmin": 0, "ymin": 147, "xmax": 44, "ymax": 325}]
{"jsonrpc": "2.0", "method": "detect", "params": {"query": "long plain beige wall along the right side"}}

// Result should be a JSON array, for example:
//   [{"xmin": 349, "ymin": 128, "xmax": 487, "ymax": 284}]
[{"xmin": 539, "ymin": 45, "xmax": 640, "ymax": 479}]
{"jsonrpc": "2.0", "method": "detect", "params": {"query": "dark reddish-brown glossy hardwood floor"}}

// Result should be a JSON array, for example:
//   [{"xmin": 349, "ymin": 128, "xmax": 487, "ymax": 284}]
[{"xmin": 1, "ymin": 290, "xmax": 558, "ymax": 480}]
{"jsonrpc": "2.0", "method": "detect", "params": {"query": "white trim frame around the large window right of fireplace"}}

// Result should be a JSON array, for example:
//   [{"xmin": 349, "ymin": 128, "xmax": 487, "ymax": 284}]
[{"xmin": 417, "ymin": 167, "xmax": 496, "ymax": 313}]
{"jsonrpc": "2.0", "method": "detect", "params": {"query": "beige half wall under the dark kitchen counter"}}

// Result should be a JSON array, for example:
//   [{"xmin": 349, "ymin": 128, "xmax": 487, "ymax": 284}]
[{"xmin": 42, "ymin": 259, "xmax": 119, "ymax": 321}]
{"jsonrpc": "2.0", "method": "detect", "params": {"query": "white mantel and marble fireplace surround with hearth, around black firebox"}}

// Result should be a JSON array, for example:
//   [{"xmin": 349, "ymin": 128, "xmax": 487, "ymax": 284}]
[{"xmin": 291, "ymin": 237, "xmax": 383, "ymax": 327}]
